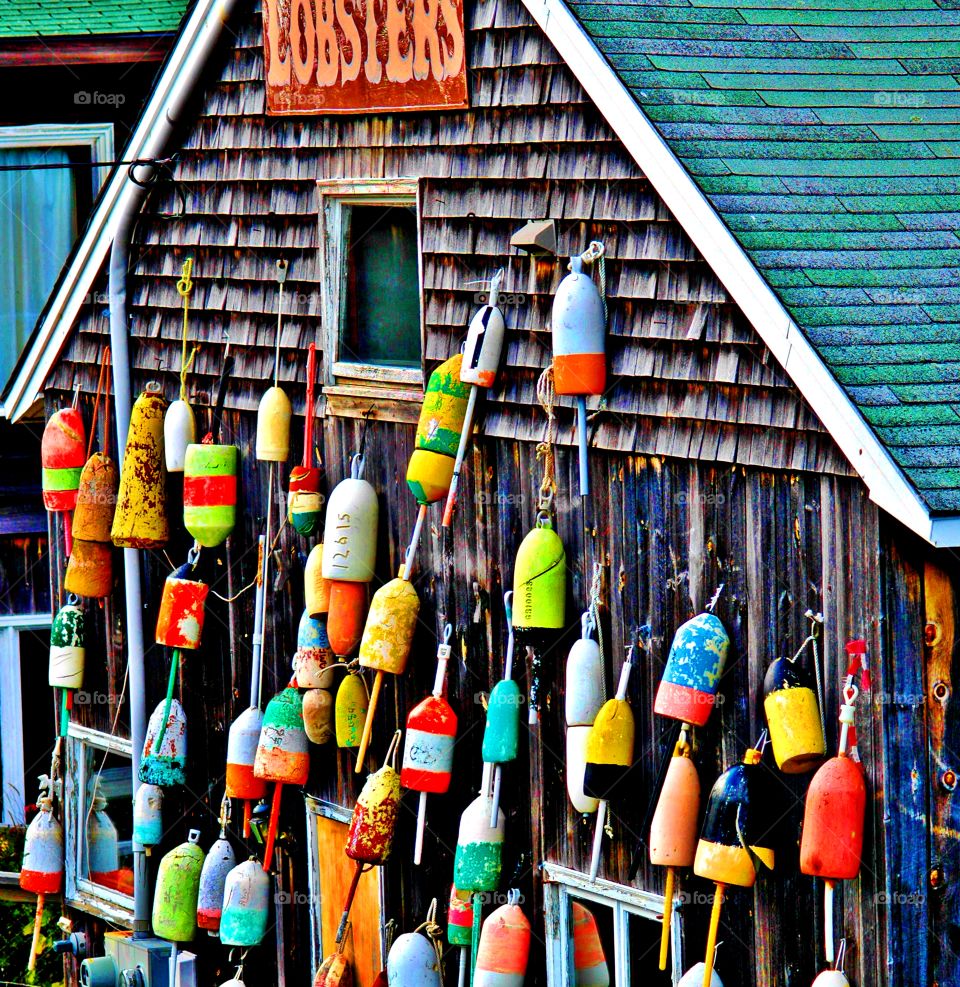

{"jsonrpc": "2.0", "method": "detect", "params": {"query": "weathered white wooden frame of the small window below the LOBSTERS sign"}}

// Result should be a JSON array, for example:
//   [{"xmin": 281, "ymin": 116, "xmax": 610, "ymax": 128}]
[{"xmin": 317, "ymin": 178, "xmax": 424, "ymax": 402}]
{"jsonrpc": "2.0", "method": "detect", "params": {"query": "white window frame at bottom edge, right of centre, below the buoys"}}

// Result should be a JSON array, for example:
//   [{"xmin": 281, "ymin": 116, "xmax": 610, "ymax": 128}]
[{"xmin": 543, "ymin": 862, "xmax": 683, "ymax": 987}]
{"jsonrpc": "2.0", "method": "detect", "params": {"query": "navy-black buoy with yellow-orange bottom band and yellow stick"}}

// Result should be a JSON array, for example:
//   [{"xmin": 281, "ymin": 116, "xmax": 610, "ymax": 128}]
[{"xmin": 693, "ymin": 747, "xmax": 774, "ymax": 987}]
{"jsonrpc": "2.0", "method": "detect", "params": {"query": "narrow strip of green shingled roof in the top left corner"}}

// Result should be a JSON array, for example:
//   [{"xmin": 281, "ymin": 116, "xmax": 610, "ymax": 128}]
[{"xmin": 0, "ymin": 0, "xmax": 187, "ymax": 38}]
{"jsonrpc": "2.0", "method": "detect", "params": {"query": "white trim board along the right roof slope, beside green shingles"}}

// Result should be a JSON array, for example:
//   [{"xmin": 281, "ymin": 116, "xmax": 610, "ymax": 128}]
[{"xmin": 523, "ymin": 0, "xmax": 960, "ymax": 546}]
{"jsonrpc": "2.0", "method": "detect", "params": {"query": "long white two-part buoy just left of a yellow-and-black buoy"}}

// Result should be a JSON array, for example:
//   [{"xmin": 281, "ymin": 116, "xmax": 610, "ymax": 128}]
[{"xmin": 565, "ymin": 610, "xmax": 604, "ymax": 814}]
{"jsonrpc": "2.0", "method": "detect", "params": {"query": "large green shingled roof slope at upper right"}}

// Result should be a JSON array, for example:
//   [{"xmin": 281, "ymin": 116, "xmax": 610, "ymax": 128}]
[{"xmin": 567, "ymin": 0, "xmax": 960, "ymax": 513}]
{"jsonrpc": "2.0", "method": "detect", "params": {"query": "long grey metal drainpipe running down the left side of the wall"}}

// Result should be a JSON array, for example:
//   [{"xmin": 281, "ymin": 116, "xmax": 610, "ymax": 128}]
[{"xmin": 108, "ymin": 0, "xmax": 236, "ymax": 939}]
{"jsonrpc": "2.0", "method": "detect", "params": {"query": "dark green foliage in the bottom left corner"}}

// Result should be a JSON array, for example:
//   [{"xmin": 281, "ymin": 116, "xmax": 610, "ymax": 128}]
[{"xmin": 0, "ymin": 827, "xmax": 63, "ymax": 987}]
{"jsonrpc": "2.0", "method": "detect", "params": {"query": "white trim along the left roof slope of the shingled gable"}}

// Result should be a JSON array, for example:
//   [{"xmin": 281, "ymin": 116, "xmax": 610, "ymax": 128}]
[{"xmin": 0, "ymin": 0, "xmax": 235, "ymax": 421}]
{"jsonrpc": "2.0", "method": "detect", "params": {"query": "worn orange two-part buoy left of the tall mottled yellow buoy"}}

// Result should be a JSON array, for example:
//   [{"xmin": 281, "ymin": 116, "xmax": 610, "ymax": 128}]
[{"xmin": 63, "ymin": 452, "xmax": 120, "ymax": 599}]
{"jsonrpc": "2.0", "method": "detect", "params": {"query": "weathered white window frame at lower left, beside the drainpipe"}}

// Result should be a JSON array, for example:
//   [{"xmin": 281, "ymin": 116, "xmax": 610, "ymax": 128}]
[{"xmin": 63, "ymin": 722, "xmax": 133, "ymax": 929}]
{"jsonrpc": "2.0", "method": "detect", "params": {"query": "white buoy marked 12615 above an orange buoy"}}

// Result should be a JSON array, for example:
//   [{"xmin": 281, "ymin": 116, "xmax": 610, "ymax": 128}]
[{"xmin": 322, "ymin": 456, "xmax": 379, "ymax": 583}]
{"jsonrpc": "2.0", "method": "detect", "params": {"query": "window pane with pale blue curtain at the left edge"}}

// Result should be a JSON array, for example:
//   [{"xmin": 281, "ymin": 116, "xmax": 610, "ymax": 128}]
[{"xmin": 0, "ymin": 147, "xmax": 77, "ymax": 386}]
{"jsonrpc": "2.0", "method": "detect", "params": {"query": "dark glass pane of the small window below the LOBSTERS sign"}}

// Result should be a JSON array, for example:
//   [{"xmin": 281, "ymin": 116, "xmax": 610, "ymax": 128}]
[{"xmin": 339, "ymin": 205, "xmax": 420, "ymax": 367}]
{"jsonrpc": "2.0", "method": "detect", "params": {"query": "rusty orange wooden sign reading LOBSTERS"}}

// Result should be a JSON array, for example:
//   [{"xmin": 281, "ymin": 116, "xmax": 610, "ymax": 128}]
[{"xmin": 263, "ymin": 0, "xmax": 469, "ymax": 115}]
